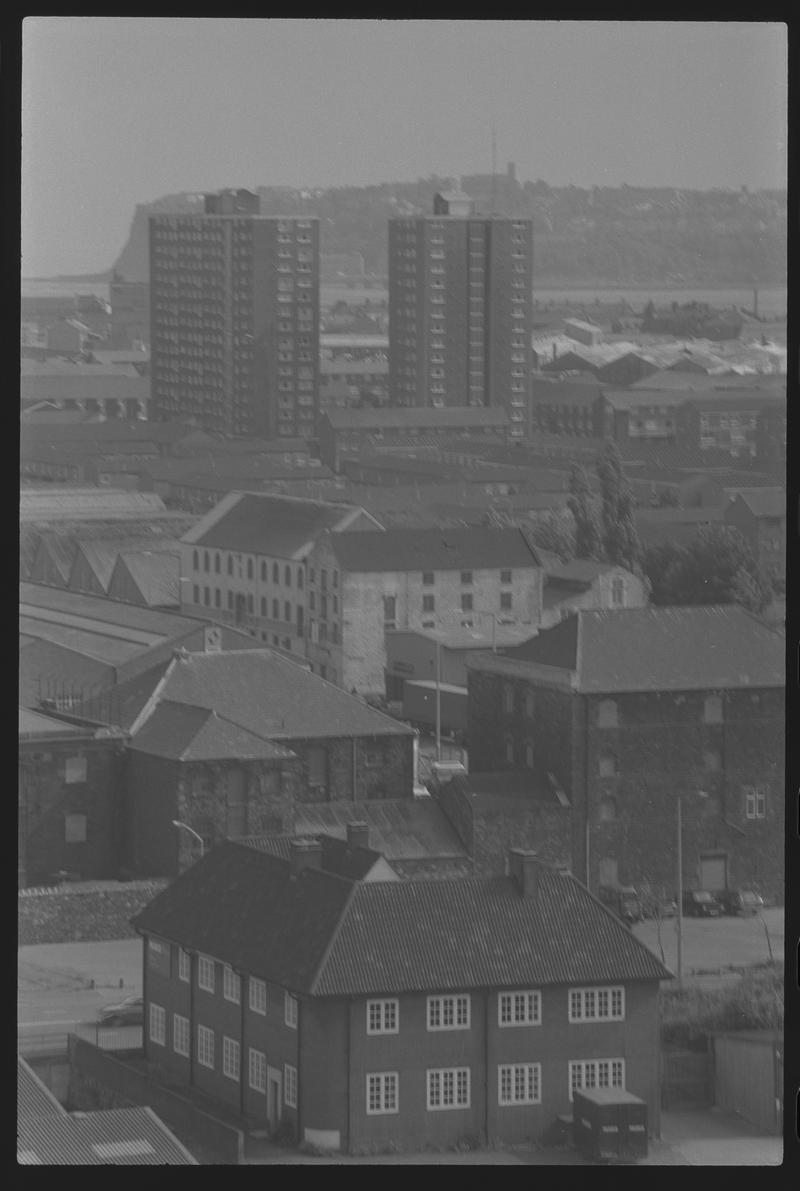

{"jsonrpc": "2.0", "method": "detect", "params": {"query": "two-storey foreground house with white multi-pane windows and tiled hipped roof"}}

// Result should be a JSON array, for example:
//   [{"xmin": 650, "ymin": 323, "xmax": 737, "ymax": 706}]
[{"xmin": 135, "ymin": 840, "xmax": 669, "ymax": 1153}]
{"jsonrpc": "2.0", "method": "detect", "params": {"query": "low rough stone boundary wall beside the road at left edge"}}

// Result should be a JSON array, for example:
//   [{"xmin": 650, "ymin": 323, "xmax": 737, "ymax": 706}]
[{"xmin": 18, "ymin": 881, "xmax": 167, "ymax": 947}]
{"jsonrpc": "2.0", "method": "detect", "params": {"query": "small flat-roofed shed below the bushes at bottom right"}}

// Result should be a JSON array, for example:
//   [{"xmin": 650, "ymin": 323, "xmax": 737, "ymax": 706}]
[{"xmin": 713, "ymin": 1030, "xmax": 783, "ymax": 1134}]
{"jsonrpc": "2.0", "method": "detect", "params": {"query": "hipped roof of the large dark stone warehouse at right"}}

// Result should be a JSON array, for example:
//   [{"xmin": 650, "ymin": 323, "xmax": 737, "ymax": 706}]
[{"xmin": 506, "ymin": 604, "xmax": 786, "ymax": 694}]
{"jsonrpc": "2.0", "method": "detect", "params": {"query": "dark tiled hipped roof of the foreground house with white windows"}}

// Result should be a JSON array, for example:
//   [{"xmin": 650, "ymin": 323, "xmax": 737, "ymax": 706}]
[{"xmin": 132, "ymin": 843, "xmax": 669, "ymax": 997}]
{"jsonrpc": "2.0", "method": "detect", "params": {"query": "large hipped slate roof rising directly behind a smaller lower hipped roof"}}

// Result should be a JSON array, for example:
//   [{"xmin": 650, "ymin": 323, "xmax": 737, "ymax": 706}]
[{"xmin": 114, "ymin": 649, "xmax": 413, "ymax": 741}]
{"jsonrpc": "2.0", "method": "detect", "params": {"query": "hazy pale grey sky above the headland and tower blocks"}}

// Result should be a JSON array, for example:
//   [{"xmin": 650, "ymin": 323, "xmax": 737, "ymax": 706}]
[{"xmin": 23, "ymin": 17, "xmax": 787, "ymax": 276}]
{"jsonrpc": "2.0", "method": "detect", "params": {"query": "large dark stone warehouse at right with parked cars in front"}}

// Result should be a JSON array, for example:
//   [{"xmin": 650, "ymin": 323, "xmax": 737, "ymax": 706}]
[{"xmin": 467, "ymin": 605, "xmax": 786, "ymax": 899}]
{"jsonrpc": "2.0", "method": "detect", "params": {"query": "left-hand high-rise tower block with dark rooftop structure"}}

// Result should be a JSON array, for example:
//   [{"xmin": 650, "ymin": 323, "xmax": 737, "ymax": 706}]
[{"xmin": 150, "ymin": 191, "xmax": 319, "ymax": 437}]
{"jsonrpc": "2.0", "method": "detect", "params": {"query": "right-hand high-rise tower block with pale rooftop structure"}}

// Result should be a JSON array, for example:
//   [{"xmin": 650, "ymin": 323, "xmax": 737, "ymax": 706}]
[{"xmin": 389, "ymin": 192, "xmax": 533, "ymax": 437}]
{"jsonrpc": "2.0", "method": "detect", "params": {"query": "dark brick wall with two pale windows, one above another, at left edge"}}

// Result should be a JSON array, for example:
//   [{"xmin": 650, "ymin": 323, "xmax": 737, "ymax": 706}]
[{"xmin": 18, "ymin": 741, "xmax": 123, "ymax": 886}]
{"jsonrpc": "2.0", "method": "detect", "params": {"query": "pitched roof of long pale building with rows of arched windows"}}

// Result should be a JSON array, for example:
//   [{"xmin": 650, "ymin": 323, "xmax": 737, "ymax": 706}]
[{"xmin": 185, "ymin": 492, "xmax": 371, "ymax": 559}]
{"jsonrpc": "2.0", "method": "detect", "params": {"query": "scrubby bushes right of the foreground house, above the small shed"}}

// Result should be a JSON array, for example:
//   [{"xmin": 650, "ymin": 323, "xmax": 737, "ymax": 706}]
[{"xmin": 660, "ymin": 962, "xmax": 783, "ymax": 1047}]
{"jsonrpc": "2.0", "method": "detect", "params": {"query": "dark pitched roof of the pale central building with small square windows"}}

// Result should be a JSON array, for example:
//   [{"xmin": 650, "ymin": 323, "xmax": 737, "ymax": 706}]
[{"xmin": 331, "ymin": 526, "xmax": 539, "ymax": 573}]
